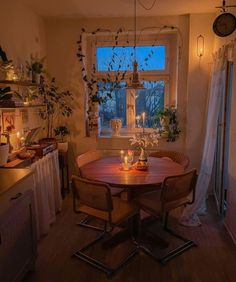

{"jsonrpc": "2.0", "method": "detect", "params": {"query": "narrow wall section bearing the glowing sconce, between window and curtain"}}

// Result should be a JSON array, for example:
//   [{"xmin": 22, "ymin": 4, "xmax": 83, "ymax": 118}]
[{"xmin": 186, "ymin": 14, "xmax": 214, "ymax": 168}]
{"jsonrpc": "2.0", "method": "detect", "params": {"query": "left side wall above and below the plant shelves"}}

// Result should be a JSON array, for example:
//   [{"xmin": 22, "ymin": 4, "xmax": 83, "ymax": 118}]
[{"xmin": 0, "ymin": 0, "xmax": 46, "ymax": 148}]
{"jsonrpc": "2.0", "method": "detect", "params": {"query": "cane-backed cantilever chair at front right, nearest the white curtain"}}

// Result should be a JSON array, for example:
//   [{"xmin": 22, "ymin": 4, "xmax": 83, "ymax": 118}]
[{"xmin": 136, "ymin": 169, "xmax": 197, "ymax": 264}]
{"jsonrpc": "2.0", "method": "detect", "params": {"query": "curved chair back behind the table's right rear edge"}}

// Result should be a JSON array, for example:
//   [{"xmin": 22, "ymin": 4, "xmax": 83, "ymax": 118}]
[{"xmin": 150, "ymin": 150, "xmax": 189, "ymax": 169}]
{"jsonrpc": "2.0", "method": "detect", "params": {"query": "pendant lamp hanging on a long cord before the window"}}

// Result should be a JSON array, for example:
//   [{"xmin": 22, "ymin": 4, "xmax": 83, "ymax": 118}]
[{"xmin": 127, "ymin": 0, "xmax": 144, "ymax": 89}]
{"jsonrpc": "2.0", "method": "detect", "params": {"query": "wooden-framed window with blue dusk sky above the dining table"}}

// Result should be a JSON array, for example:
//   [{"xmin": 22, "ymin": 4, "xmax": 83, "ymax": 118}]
[{"xmin": 92, "ymin": 33, "xmax": 177, "ymax": 133}]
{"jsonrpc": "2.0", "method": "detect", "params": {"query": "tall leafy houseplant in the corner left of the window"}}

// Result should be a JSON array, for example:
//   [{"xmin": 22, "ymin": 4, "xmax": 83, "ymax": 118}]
[{"xmin": 38, "ymin": 77, "xmax": 73, "ymax": 138}]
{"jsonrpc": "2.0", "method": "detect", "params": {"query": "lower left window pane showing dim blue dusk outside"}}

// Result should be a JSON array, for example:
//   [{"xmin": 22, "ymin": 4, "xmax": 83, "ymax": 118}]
[{"xmin": 98, "ymin": 82, "xmax": 126, "ymax": 128}]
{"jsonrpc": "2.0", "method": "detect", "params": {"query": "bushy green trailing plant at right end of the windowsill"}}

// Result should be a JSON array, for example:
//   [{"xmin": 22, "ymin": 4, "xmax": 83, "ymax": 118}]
[{"xmin": 157, "ymin": 106, "xmax": 181, "ymax": 142}]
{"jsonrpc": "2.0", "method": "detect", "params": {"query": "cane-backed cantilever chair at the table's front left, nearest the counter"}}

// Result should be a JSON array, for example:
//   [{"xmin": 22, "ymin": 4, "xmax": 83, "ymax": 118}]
[{"xmin": 72, "ymin": 176, "xmax": 139, "ymax": 275}]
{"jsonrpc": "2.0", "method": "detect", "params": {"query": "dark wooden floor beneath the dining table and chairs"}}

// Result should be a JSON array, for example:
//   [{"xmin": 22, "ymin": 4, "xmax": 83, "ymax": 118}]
[{"xmin": 26, "ymin": 196, "xmax": 236, "ymax": 282}]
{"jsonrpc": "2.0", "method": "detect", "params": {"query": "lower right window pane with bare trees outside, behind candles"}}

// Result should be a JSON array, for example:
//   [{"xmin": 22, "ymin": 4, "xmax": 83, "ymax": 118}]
[{"xmin": 136, "ymin": 80, "xmax": 165, "ymax": 127}]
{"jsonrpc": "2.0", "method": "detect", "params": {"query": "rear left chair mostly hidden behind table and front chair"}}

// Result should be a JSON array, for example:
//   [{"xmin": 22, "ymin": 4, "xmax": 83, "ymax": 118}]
[{"xmin": 74, "ymin": 149, "xmax": 124, "ymax": 230}]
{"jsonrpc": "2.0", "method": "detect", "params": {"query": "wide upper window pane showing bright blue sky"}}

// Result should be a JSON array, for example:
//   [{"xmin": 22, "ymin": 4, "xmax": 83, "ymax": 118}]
[{"xmin": 96, "ymin": 45, "xmax": 166, "ymax": 71}]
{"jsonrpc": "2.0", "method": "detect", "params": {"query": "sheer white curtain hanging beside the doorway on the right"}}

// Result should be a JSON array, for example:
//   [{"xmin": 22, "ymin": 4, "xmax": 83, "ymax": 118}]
[{"xmin": 180, "ymin": 45, "xmax": 231, "ymax": 226}]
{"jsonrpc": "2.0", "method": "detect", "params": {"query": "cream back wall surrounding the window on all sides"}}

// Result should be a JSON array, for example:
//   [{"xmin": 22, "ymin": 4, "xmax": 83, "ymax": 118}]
[{"xmin": 46, "ymin": 14, "xmax": 213, "ymax": 170}]
